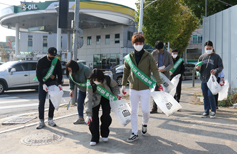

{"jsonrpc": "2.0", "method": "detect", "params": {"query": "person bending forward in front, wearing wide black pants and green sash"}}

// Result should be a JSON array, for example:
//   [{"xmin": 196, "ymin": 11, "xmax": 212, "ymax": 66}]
[{"xmin": 85, "ymin": 69, "xmax": 121, "ymax": 146}]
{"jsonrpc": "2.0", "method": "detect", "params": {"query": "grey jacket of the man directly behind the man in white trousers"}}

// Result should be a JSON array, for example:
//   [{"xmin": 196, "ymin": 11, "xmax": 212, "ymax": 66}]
[{"xmin": 151, "ymin": 50, "xmax": 174, "ymax": 79}]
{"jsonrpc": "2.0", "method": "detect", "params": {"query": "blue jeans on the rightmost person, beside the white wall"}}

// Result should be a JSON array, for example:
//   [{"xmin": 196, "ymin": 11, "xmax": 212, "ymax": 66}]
[{"xmin": 201, "ymin": 83, "xmax": 216, "ymax": 114}]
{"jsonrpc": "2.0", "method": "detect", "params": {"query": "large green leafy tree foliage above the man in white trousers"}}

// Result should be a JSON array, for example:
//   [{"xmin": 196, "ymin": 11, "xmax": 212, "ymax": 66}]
[{"xmin": 136, "ymin": 0, "xmax": 199, "ymax": 55}]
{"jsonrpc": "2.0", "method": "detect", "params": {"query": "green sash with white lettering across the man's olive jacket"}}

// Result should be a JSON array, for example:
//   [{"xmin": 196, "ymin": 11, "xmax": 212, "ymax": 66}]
[{"xmin": 124, "ymin": 54, "xmax": 156, "ymax": 88}]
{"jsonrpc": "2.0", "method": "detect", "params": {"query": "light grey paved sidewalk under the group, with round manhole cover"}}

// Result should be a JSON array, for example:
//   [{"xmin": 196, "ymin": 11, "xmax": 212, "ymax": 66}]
[{"xmin": 0, "ymin": 87, "xmax": 237, "ymax": 154}]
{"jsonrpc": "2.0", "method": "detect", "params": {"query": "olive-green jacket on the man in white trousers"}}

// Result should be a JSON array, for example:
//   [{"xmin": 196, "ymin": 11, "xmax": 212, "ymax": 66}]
[{"xmin": 122, "ymin": 50, "xmax": 162, "ymax": 90}]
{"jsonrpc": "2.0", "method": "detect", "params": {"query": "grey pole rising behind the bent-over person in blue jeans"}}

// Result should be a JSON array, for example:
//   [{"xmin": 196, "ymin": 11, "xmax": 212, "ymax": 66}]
[{"xmin": 72, "ymin": 0, "xmax": 80, "ymax": 105}]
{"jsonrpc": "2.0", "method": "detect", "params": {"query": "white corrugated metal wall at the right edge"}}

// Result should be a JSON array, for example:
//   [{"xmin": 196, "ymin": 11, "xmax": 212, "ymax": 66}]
[{"xmin": 203, "ymin": 5, "xmax": 237, "ymax": 88}]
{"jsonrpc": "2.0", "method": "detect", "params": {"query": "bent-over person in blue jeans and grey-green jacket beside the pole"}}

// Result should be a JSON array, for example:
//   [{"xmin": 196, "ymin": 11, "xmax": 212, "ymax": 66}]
[{"xmin": 66, "ymin": 60, "xmax": 91, "ymax": 125}]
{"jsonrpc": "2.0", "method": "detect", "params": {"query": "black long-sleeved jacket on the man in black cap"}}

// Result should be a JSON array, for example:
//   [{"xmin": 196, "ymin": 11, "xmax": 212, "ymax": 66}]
[{"xmin": 36, "ymin": 56, "xmax": 63, "ymax": 85}]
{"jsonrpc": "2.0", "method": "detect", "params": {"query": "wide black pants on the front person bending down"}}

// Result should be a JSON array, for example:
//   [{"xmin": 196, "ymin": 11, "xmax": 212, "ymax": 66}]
[{"xmin": 89, "ymin": 97, "xmax": 112, "ymax": 143}]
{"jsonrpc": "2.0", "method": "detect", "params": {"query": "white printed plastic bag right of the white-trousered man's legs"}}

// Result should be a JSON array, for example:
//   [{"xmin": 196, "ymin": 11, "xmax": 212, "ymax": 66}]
[{"xmin": 151, "ymin": 91, "xmax": 182, "ymax": 116}]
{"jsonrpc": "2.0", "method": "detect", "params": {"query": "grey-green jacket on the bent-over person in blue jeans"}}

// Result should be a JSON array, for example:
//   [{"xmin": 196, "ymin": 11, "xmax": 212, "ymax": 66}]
[{"xmin": 69, "ymin": 62, "xmax": 91, "ymax": 92}]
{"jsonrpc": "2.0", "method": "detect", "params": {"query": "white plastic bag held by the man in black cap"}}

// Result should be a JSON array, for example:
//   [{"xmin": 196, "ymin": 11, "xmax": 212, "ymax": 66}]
[{"xmin": 48, "ymin": 85, "xmax": 64, "ymax": 110}]
